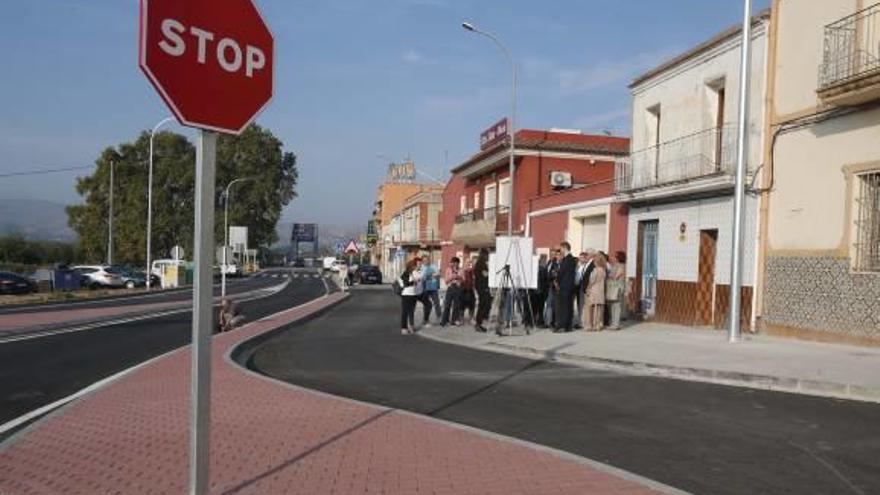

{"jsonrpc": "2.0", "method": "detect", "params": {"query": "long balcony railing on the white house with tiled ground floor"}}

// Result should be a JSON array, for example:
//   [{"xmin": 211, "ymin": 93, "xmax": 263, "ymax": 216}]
[{"xmin": 614, "ymin": 125, "xmax": 736, "ymax": 193}]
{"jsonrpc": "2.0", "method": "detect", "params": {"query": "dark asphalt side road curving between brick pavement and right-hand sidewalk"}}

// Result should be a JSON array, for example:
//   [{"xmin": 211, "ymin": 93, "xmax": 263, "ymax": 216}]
[{"xmin": 251, "ymin": 290, "xmax": 880, "ymax": 495}]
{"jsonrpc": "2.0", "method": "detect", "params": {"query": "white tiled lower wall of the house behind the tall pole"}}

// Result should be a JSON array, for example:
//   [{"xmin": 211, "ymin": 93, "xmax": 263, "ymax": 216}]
[{"xmin": 627, "ymin": 196, "xmax": 757, "ymax": 285}]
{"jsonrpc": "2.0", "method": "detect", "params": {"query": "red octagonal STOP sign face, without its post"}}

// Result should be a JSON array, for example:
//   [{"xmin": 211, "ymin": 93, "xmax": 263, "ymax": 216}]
[{"xmin": 140, "ymin": 0, "xmax": 273, "ymax": 134}]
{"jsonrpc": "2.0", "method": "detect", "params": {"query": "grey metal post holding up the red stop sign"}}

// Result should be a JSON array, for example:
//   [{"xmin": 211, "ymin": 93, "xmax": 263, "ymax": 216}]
[{"xmin": 190, "ymin": 130, "xmax": 217, "ymax": 495}]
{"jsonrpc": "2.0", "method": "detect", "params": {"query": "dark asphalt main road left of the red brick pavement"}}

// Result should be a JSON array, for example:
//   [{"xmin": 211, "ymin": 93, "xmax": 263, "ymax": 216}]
[{"xmin": 0, "ymin": 270, "xmax": 325, "ymax": 424}]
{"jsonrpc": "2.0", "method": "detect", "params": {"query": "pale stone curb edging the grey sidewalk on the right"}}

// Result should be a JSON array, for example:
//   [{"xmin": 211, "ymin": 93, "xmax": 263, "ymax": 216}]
[{"xmin": 416, "ymin": 332, "xmax": 880, "ymax": 404}]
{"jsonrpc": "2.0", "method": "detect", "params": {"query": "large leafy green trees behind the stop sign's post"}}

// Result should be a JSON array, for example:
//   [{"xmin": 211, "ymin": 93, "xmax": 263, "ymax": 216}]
[{"xmin": 67, "ymin": 125, "xmax": 298, "ymax": 264}]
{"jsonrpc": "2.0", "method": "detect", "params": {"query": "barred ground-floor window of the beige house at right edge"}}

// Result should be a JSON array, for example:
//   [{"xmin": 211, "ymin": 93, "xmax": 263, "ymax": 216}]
[{"xmin": 854, "ymin": 172, "xmax": 880, "ymax": 273}]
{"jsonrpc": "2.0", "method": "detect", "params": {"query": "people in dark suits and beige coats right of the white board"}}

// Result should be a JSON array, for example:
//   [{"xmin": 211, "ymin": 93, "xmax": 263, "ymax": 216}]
[{"xmin": 535, "ymin": 242, "xmax": 626, "ymax": 332}]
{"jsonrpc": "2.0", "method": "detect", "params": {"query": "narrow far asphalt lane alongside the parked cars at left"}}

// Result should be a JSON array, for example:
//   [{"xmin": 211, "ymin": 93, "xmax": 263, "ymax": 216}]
[{"xmin": 0, "ymin": 272, "xmax": 279, "ymax": 315}]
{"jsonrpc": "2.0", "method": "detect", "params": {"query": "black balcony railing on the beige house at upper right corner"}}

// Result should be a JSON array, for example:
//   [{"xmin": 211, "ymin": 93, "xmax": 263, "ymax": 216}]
[{"xmin": 819, "ymin": 3, "xmax": 880, "ymax": 90}]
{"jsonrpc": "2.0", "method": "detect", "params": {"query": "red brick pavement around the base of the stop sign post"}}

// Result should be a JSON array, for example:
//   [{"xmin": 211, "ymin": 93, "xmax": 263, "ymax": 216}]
[{"xmin": 0, "ymin": 294, "xmax": 680, "ymax": 495}]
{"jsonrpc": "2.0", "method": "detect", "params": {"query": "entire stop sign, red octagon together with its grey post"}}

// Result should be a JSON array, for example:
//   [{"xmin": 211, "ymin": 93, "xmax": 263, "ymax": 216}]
[{"xmin": 139, "ymin": 0, "xmax": 274, "ymax": 495}]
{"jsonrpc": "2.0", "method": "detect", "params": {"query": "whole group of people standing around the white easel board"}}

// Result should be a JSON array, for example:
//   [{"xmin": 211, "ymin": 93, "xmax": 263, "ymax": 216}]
[{"xmin": 397, "ymin": 242, "xmax": 626, "ymax": 335}]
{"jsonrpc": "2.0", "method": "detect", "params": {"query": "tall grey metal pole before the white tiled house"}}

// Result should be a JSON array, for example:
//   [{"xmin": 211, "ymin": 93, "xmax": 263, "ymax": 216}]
[{"xmin": 727, "ymin": 0, "xmax": 752, "ymax": 343}]
